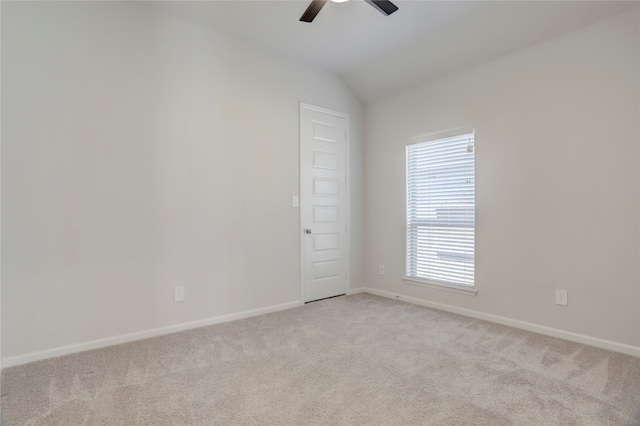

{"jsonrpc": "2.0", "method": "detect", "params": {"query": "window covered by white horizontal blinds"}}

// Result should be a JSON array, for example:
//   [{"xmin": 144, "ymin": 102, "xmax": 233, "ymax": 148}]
[{"xmin": 405, "ymin": 132, "xmax": 475, "ymax": 294}]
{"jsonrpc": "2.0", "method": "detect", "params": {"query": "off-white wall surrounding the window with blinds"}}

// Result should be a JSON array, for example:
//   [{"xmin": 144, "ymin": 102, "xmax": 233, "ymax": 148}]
[{"xmin": 365, "ymin": 9, "xmax": 640, "ymax": 347}]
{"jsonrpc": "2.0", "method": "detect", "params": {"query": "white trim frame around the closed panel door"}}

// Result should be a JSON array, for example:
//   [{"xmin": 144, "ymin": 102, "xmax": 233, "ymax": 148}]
[{"xmin": 298, "ymin": 102, "xmax": 351, "ymax": 303}]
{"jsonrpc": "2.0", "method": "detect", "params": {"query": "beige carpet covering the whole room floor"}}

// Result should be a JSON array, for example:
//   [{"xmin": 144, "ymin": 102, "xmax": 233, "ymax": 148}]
[{"xmin": 1, "ymin": 294, "xmax": 640, "ymax": 426}]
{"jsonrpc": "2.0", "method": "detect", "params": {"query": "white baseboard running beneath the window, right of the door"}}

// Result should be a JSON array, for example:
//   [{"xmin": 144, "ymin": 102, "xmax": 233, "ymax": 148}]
[{"xmin": 358, "ymin": 287, "xmax": 640, "ymax": 357}]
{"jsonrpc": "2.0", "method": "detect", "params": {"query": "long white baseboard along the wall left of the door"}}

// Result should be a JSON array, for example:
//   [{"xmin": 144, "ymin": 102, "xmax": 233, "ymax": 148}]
[{"xmin": 1, "ymin": 300, "xmax": 304, "ymax": 368}]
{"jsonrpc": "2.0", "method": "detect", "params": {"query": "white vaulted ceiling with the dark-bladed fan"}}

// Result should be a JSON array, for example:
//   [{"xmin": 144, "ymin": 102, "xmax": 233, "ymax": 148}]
[{"xmin": 148, "ymin": 0, "xmax": 640, "ymax": 104}]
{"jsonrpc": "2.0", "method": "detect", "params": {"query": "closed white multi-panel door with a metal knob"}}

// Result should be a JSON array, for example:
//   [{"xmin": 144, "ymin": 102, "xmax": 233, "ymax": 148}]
[{"xmin": 300, "ymin": 104, "xmax": 349, "ymax": 302}]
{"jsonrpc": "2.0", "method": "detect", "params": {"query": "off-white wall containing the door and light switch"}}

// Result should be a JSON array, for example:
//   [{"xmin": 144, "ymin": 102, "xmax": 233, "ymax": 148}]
[{"xmin": 2, "ymin": 2, "xmax": 363, "ymax": 359}]
